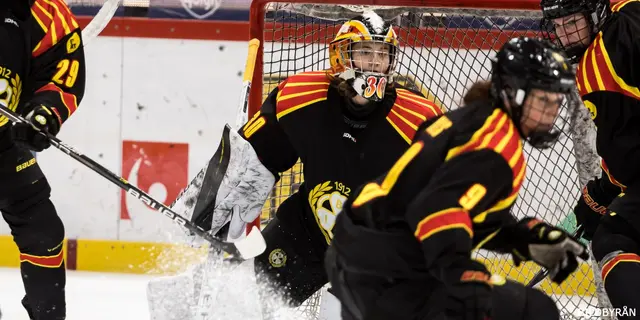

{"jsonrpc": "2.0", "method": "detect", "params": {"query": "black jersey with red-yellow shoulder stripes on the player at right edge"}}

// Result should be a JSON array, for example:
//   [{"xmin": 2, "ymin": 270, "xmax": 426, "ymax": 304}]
[{"xmin": 576, "ymin": 0, "xmax": 640, "ymax": 190}]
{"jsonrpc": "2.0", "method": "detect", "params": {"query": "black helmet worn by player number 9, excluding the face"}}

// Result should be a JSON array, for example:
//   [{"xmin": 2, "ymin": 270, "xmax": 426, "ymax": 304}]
[{"xmin": 490, "ymin": 37, "xmax": 577, "ymax": 149}]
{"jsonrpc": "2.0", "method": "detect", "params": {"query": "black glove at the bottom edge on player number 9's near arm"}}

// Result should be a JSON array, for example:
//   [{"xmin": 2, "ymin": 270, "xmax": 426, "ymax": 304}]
[{"xmin": 444, "ymin": 259, "xmax": 492, "ymax": 320}]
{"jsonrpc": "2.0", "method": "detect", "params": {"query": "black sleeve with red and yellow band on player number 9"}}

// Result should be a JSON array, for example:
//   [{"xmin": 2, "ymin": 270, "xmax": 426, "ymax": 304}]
[{"xmin": 405, "ymin": 149, "xmax": 513, "ymax": 282}]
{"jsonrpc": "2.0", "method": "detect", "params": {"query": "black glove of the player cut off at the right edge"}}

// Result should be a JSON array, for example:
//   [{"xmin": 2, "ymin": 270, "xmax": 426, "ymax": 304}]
[{"xmin": 573, "ymin": 178, "xmax": 620, "ymax": 241}]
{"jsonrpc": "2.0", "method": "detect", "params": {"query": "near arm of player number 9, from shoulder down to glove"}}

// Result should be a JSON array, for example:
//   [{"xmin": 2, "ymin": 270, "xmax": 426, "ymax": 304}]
[{"xmin": 406, "ymin": 149, "xmax": 513, "ymax": 319}]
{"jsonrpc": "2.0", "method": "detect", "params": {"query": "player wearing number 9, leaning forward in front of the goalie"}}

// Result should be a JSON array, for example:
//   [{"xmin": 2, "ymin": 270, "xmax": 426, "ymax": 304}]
[{"xmin": 326, "ymin": 38, "xmax": 588, "ymax": 320}]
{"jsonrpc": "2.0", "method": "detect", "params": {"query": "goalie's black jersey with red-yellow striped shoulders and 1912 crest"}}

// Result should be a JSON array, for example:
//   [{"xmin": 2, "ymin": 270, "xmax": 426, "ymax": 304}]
[{"xmin": 241, "ymin": 71, "xmax": 442, "ymax": 252}]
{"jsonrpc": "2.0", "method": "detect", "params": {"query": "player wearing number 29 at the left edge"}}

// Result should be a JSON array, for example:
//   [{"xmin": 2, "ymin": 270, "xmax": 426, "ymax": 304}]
[{"xmin": 0, "ymin": 0, "xmax": 85, "ymax": 320}]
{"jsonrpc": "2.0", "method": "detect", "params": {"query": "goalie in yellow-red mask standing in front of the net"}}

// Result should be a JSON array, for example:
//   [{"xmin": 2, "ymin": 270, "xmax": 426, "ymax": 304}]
[{"xmin": 164, "ymin": 12, "xmax": 442, "ymax": 316}]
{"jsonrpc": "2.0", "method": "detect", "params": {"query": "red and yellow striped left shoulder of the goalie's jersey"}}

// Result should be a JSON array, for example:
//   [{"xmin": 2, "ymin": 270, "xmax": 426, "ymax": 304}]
[{"xmin": 276, "ymin": 71, "xmax": 331, "ymax": 119}]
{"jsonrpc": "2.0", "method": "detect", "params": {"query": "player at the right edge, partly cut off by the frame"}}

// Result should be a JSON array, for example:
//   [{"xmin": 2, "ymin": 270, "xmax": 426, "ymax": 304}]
[{"xmin": 541, "ymin": 0, "xmax": 640, "ymax": 318}]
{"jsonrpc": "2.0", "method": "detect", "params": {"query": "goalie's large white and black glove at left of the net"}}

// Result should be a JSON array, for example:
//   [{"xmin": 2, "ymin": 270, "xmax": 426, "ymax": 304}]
[{"xmin": 171, "ymin": 125, "xmax": 276, "ymax": 241}]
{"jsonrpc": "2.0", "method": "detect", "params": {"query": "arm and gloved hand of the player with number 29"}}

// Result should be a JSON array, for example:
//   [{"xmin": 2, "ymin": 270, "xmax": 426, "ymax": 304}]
[{"xmin": 12, "ymin": 0, "xmax": 85, "ymax": 151}]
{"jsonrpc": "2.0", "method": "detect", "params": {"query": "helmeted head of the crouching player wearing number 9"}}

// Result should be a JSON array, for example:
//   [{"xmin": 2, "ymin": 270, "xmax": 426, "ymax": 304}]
[{"xmin": 491, "ymin": 37, "xmax": 578, "ymax": 149}]
